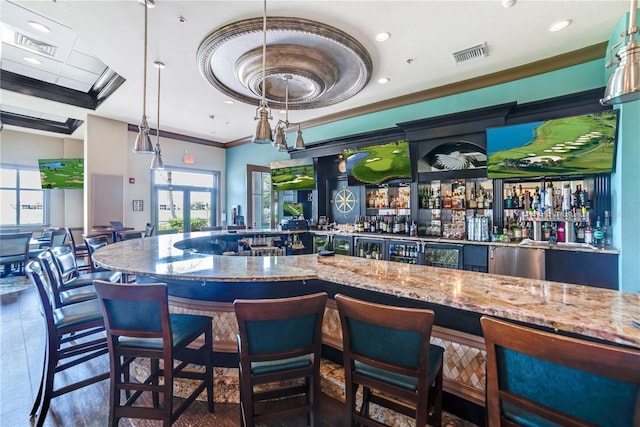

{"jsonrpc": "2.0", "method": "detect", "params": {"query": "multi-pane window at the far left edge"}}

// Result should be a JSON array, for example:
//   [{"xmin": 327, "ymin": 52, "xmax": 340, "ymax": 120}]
[{"xmin": 0, "ymin": 165, "xmax": 49, "ymax": 226}]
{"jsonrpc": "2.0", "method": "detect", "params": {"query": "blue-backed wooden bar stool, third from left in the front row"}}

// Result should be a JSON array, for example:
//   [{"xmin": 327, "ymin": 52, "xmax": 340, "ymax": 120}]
[{"xmin": 335, "ymin": 294, "xmax": 444, "ymax": 426}]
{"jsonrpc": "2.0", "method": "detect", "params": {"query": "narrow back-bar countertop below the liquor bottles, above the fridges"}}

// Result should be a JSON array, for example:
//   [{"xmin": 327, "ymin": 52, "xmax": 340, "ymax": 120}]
[{"xmin": 309, "ymin": 230, "xmax": 620, "ymax": 254}]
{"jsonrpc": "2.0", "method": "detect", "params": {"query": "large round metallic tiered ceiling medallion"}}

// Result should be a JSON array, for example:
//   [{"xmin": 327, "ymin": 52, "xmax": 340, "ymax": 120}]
[{"xmin": 197, "ymin": 16, "xmax": 372, "ymax": 110}]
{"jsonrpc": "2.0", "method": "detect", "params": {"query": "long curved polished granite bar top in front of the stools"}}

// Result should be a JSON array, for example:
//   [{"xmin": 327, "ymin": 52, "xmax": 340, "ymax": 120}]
[{"xmin": 94, "ymin": 234, "xmax": 640, "ymax": 348}]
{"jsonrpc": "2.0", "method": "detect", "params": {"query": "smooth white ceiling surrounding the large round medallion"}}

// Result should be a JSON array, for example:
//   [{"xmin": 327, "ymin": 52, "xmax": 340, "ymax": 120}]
[{"xmin": 0, "ymin": 0, "xmax": 629, "ymax": 143}]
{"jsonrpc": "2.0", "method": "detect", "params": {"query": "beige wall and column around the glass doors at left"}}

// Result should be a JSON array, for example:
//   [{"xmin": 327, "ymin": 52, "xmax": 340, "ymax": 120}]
[{"xmin": 0, "ymin": 115, "xmax": 226, "ymax": 232}]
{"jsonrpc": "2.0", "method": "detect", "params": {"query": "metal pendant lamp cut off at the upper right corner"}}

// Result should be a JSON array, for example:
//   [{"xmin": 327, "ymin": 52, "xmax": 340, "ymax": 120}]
[{"xmin": 600, "ymin": 0, "xmax": 640, "ymax": 105}]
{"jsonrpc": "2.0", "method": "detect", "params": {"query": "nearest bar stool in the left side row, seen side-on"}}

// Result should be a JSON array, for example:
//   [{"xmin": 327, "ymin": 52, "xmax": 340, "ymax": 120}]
[{"xmin": 26, "ymin": 261, "xmax": 109, "ymax": 427}]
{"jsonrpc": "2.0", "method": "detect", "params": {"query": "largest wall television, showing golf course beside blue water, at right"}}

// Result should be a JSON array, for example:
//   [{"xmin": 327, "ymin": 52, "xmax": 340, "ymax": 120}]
[{"xmin": 487, "ymin": 110, "xmax": 618, "ymax": 178}]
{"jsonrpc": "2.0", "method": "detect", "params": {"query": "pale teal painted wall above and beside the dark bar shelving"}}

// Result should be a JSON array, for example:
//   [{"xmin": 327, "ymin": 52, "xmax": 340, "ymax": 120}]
[{"xmin": 226, "ymin": 59, "xmax": 640, "ymax": 292}]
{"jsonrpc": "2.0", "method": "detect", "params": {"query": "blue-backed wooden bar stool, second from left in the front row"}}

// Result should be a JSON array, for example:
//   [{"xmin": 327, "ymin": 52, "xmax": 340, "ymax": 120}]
[{"xmin": 233, "ymin": 292, "xmax": 327, "ymax": 427}]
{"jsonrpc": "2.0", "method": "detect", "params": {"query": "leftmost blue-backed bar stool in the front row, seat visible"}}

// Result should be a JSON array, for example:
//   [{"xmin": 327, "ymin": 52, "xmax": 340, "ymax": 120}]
[{"xmin": 94, "ymin": 280, "xmax": 214, "ymax": 427}]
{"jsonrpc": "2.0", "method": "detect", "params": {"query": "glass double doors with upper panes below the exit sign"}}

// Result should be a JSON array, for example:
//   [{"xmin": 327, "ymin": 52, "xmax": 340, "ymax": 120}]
[{"xmin": 152, "ymin": 169, "xmax": 220, "ymax": 234}]
